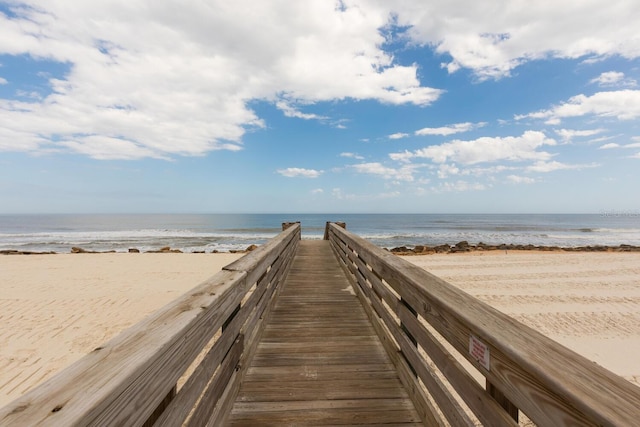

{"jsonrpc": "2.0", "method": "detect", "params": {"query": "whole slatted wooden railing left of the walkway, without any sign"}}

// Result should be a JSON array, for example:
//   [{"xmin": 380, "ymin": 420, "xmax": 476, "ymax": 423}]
[{"xmin": 0, "ymin": 223, "xmax": 300, "ymax": 426}]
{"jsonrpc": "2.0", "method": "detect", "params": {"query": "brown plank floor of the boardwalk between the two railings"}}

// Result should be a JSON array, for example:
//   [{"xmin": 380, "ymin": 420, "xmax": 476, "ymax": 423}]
[{"xmin": 229, "ymin": 241, "xmax": 422, "ymax": 426}]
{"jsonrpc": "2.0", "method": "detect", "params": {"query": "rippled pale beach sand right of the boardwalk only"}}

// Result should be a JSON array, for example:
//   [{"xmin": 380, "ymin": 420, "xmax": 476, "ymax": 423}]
[{"xmin": 404, "ymin": 251, "xmax": 640, "ymax": 392}]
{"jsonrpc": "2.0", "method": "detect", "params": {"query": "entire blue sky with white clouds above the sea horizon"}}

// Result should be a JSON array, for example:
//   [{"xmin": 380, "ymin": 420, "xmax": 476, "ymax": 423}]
[{"xmin": 0, "ymin": 0, "xmax": 640, "ymax": 213}]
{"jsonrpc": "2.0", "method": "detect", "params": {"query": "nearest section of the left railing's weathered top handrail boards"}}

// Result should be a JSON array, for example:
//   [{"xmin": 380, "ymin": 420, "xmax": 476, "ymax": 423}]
[{"xmin": 0, "ymin": 271, "xmax": 246, "ymax": 426}]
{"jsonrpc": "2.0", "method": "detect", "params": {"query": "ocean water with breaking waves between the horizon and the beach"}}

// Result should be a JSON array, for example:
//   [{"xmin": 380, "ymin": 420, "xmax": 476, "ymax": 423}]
[{"xmin": 0, "ymin": 212, "xmax": 640, "ymax": 253}]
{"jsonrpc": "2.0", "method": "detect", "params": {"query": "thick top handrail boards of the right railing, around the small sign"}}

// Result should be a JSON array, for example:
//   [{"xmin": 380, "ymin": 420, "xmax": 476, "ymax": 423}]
[{"xmin": 330, "ymin": 226, "xmax": 640, "ymax": 425}]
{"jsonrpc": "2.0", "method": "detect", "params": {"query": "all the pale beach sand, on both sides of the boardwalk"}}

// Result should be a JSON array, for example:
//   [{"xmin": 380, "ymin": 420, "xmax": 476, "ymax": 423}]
[{"xmin": 0, "ymin": 251, "xmax": 640, "ymax": 406}]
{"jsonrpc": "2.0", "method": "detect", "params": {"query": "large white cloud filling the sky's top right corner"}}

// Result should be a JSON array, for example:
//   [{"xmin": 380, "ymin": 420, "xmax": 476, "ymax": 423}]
[{"xmin": 375, "ymin": 0, "xmax": 640, "ymax": 79}]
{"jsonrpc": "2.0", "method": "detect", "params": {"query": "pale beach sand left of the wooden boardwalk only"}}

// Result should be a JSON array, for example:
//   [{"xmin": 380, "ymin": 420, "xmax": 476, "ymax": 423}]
[{"xmin": 0, "ymin": 253, "xmax": 242, "ymax": 406}]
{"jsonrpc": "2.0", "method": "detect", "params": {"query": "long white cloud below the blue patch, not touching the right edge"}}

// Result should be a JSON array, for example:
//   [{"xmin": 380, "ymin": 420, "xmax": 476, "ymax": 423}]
[{"xmin": 390, "ymin": 131, "xmax": 556, "ymax": 164}]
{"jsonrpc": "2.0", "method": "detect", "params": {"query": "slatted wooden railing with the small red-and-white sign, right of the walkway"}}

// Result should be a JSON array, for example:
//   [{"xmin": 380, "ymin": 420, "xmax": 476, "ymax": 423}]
[{"xmin": 325, "ymin": 223, "xmax": 640, "ymax": 426}]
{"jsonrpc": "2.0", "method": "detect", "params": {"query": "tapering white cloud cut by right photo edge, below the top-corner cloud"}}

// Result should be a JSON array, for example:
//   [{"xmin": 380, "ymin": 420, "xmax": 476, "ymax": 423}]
[{"xmin": 515, "ymin": 89, "xmax": 640, "ymax": 124}]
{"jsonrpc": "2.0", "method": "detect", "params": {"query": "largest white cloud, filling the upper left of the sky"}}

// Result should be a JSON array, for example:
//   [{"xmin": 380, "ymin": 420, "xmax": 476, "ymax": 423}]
[{"xmin": 0, "ymin": 0, "xmax": 441, "ymax": 158}]
